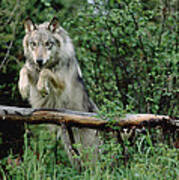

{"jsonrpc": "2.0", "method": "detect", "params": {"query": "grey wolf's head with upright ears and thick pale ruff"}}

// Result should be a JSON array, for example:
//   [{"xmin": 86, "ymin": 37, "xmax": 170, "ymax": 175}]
[{"xmin": 23, "ymin": 18, "xmax": 74, "ymax": 68}]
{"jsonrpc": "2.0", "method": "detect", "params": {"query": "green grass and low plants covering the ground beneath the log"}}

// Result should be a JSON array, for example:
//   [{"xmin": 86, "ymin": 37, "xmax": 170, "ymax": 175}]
[{"xmin": 0, "ymin": 127, "xmax": 179, "ymax": 180}]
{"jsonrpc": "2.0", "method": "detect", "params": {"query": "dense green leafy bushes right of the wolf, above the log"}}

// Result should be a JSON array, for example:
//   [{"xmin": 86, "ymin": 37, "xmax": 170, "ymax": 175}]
[{"xmin": 65, "ymin": 0, "xmax": 179, "ymax": 115}]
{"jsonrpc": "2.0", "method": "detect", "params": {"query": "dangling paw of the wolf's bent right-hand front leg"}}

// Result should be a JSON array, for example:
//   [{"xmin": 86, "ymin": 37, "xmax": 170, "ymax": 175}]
[{"xmin": 37, "ymin": 69, "xmax": 50, "ymax": 97}]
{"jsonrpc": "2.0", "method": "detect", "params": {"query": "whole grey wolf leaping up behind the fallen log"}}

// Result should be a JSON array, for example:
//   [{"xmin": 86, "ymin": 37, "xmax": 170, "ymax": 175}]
[{"xmin": 18, "ymin": 18, "xmax": 100, "ymax": 169}]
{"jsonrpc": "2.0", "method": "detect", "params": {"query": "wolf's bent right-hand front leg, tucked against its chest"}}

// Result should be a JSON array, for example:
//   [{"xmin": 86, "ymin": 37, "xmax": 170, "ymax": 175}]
[{"xmin": 37, "ymin": 69, "xmax": 65, "ymax": 96}]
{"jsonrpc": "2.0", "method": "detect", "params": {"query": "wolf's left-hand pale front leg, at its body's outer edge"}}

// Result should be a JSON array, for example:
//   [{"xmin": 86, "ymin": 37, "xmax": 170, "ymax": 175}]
[{"xmin": 18, "ymin": 66, "xmax": 31, "ymax": 99}]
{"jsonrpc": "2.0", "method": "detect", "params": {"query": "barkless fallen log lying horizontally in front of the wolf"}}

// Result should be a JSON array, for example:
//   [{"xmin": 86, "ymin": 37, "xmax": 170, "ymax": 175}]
[{"xmin": 0, "ymin": 106, "xmax": 179, "ymax": 130}]
